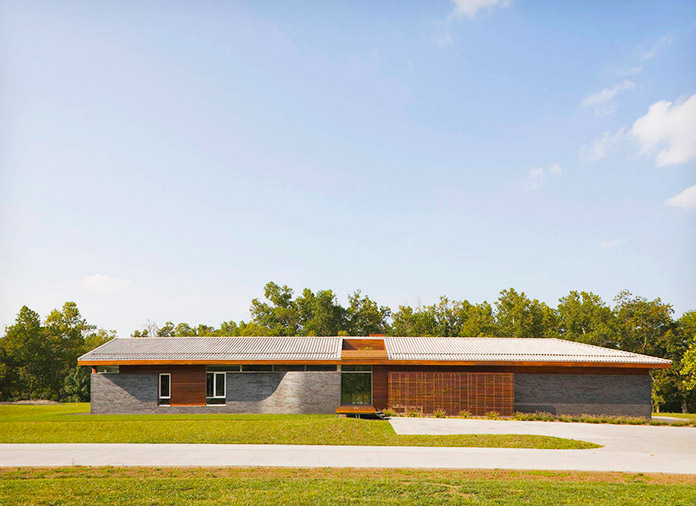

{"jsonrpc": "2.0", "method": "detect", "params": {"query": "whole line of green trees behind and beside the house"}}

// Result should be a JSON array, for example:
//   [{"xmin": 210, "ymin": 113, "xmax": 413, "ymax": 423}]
[{"xmin": 0, "ymin": 282, "xmax": 696, "ymax": 411}]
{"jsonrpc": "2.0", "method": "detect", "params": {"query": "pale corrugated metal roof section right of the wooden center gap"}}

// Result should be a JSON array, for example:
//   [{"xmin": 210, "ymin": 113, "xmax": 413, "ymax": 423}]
[{"xmin": 385, "ymin": 337, "xmax": 670, "ymax": 364}]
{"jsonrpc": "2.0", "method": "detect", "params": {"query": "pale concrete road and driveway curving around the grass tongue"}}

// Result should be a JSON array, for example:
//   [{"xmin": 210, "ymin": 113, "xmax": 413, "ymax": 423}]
[{"xmin": 0, "ymin": 418, "xmax": 696, "ymax": 474}]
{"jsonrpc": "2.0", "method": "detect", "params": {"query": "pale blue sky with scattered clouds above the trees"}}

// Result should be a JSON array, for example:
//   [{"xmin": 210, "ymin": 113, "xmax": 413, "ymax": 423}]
[{"xmin": 0, "ymin": 0, "xmax": 696, "ymax": 335}]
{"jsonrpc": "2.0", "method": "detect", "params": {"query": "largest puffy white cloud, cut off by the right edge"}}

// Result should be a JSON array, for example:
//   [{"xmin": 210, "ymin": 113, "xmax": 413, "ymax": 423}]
[{"xmin": 631, "ymin": 94, "xmax": 696, "ymax": 167}]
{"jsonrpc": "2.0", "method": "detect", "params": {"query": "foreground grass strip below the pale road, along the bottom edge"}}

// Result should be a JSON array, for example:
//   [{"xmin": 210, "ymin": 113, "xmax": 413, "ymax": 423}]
[{"xmin": 0, "ymin": 468, "xmax": 696, "ymax": 505}]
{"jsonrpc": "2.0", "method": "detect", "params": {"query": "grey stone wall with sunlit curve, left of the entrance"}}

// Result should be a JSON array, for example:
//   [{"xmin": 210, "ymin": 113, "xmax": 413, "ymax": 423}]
[{"xmin": 92, "ymin": 372, "xmax": 341, "ymax": 414}]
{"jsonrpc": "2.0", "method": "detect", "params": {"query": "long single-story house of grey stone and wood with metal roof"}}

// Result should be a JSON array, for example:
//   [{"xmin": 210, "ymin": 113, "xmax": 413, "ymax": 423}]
[{"xmin": 78, "ymin": 336, "xmax": 670, "ymax": 417}]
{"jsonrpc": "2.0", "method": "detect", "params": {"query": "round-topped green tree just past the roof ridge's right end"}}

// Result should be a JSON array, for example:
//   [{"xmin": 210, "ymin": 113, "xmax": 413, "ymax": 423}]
[{"xmin": 557, "ymin": 291, "xmax": 617, "ymax": 348}]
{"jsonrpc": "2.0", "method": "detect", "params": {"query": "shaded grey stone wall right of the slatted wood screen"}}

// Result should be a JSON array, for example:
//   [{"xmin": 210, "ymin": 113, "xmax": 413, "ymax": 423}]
[{"xmin": 515, "ymin": 374, "xmax": 651, "ymax": 418}]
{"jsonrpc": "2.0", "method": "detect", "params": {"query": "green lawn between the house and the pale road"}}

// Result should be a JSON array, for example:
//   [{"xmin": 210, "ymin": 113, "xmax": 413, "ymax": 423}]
[{"xmin": 0, "ymin": 404, "xmax": 598, "ymax": 449}]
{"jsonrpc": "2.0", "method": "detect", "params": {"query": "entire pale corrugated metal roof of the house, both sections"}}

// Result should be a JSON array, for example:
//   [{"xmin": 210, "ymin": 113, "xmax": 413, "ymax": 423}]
[{"xmin": 78, "ymin": 337, "xmax": 670, "ymax": 366}]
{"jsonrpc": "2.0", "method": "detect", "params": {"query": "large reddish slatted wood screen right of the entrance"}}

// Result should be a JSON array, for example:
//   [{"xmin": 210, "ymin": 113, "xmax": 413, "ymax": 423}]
[{"xmin": 389, "ymin": 371, "xmax": 515, "ymax": 416}]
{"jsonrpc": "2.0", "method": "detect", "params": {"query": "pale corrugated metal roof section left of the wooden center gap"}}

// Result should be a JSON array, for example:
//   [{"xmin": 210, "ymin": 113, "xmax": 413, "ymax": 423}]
[{"xmin": 78, "ymin": 337, "xmax": 342, "ymax": 361}]
